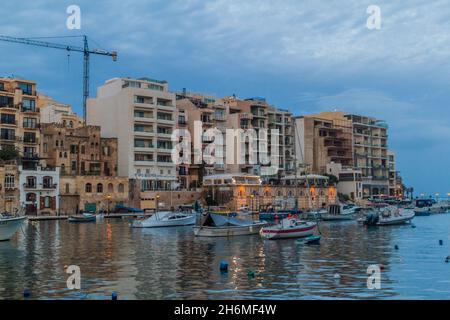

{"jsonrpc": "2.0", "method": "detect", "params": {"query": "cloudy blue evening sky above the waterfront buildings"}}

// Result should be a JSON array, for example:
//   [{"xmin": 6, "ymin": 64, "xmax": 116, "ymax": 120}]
[{"xmin": 0, "ymin": 0, "xmax": 450, "ymax": 195}]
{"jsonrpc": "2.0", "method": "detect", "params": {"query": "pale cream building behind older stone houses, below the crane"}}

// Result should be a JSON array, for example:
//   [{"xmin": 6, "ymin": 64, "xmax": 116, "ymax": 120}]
[{"xmin": 38, "ymin": 93, "xmax": 84, "ymax": 128}]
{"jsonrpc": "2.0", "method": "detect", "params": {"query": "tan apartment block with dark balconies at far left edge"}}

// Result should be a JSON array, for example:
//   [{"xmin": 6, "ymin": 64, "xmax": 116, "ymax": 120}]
[{"xmin": 0, "ymin": 78, "xmax": 40, "ymax": 169}]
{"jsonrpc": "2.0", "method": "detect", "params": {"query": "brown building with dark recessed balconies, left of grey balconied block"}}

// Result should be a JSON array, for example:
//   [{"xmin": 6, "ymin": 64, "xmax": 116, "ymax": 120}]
[{"xmin": 295, "ymin": 112, "xmax": 354, "ymax": 174}]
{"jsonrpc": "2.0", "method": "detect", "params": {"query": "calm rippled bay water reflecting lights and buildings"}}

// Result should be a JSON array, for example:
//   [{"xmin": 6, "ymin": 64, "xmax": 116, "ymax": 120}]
[{"xmin": 0, "ymin": 214, "xmax": 450, "ymax": 299}]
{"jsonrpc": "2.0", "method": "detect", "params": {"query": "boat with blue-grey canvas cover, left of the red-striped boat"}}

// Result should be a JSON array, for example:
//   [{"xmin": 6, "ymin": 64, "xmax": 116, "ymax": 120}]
[{"xmin": 194, "ymin": 213, "xmax": 267, "ymax": 237}]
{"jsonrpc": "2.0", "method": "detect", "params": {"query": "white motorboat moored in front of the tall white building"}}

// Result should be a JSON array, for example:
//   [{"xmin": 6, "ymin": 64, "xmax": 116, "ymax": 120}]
[{"xmin": 131, "ymin": 211, "xmax": 197, "ymax": 228}]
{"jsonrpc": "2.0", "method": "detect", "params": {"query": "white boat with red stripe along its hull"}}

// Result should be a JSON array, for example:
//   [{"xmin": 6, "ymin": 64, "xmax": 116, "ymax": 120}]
[{"xmin": 260, "ymin": 218, "xmax": 317, "ymax": 240}]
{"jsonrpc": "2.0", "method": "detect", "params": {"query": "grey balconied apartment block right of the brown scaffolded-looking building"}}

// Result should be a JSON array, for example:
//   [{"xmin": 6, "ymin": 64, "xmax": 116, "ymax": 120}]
[{"xmin": 339, "ymin": 114, "xmax": 389, "ymax": 198}]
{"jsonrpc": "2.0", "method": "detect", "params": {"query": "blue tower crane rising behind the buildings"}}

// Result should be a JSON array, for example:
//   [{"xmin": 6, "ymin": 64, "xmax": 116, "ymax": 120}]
[{"xmin": 0, "ymin": 35, "xmax": 117, "ymax": 124}]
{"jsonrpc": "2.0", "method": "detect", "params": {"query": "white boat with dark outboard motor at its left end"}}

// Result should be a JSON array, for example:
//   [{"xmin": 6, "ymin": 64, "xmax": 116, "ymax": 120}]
[{"xmin": 363, "ymin": 206, "xmax": 415, "ymax": 226}]
